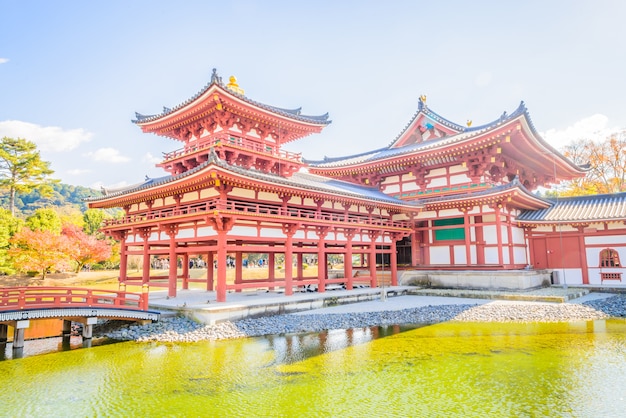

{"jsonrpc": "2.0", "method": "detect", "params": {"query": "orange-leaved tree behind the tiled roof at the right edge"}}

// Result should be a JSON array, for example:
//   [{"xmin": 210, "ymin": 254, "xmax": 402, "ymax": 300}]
[{"xmin": 560, "ymin": 130, "xmax": 626, "ymax": 196}]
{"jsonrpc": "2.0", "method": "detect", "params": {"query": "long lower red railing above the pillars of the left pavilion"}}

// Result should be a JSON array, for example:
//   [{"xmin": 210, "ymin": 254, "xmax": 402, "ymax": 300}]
[{"xmin": 104, "ymin": 199, "xmax": 406, "ymax": 228}]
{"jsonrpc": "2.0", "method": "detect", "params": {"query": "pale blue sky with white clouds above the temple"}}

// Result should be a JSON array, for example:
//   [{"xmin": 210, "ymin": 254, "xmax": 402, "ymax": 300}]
[{"xmin": 0, "ymin": 0, "xmax": 626, "ymax": 187}]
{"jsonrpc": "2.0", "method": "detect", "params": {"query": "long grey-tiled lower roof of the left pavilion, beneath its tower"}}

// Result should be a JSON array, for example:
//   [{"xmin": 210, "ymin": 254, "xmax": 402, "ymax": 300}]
[{"xmin": 85, "ymin": 150, "xmax": 421, "ymax": 209}]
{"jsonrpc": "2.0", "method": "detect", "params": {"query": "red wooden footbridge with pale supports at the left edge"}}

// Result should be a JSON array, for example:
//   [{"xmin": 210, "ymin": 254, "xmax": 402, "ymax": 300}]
[{"xmin": 0, "ymin": 286, "xmax": 160, "ymax": 349}]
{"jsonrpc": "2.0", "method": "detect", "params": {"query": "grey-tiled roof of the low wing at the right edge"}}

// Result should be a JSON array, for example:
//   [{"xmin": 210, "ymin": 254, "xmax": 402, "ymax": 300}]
[{"xmin": 517, "ymin": 193, "xmax": 626, "ymax": 224}]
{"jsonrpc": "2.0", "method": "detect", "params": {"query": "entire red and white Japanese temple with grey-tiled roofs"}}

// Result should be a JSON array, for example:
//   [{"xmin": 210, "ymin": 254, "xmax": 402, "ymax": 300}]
[{"xmin": 89, "ymin": 70, "xmax": 626, "ymax": 301}]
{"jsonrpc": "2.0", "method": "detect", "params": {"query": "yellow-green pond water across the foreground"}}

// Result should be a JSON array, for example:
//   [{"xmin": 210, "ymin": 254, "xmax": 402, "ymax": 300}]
[{"xmin": 0, "ymin": 320, "xmax": 626, "ymax": 417}]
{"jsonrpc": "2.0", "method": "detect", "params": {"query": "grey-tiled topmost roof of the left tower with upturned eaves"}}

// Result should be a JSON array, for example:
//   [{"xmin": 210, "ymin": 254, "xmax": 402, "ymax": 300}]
[{"xmin": 132, "ymin": 68, "xmax": 331, "ymax": 125}]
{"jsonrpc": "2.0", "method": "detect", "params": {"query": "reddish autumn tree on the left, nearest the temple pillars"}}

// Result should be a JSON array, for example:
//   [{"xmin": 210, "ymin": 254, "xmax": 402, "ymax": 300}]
[{"xmin": 62, "ymin": 224, "xmax": 111, "ymax": 273}]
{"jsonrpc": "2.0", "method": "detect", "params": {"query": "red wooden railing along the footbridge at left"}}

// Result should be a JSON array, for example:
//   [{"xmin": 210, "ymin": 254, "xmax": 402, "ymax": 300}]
[{"xmin": 0, "ymin": 286, "xmax": 148, "ymax": 311}]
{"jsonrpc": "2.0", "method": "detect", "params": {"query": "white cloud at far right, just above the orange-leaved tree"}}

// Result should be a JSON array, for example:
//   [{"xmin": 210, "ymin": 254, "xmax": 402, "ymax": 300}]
[{"xmin": 541, "ymin": 113, "xmax": 619, "ymax": 149}]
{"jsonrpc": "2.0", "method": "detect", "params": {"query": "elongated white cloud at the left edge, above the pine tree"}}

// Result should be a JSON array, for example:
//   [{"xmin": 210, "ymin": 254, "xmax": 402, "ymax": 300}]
[{"xmin": 0, "ymin": 120, "xmax": 93, "ymax": 152}]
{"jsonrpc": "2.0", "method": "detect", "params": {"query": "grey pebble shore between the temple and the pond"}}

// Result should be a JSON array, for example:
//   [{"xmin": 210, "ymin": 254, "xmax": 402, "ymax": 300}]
[{"xmin": 94, "ymin": 295, "xmax": 626, "ymax": 342}]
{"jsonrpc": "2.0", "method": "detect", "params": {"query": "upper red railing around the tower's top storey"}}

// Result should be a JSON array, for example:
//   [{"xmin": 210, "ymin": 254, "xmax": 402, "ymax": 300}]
[{"xmin": 163, "ymin": 134, "xmax": 302, "ymax": 162}]
